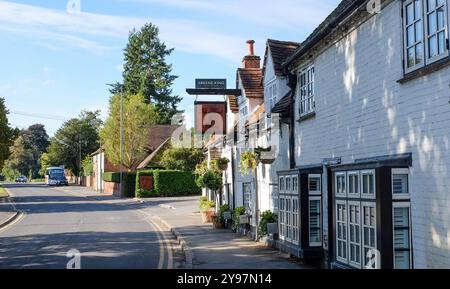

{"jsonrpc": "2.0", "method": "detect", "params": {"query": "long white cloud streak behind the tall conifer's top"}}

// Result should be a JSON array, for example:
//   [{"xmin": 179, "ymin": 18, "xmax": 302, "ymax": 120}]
[{"xmin": 0, "ymin": 1, "xmax": 248, "ymax": 61}]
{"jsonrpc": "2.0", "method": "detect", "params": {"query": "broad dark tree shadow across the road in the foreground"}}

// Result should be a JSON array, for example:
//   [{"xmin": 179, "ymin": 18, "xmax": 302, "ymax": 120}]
[{"xmin": 0, "ymin": 231, "xmax": 167, "ymax": 269}]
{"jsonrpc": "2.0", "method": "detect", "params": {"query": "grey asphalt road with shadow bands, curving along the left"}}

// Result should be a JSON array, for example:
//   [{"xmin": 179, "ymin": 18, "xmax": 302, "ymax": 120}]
[{"xmin": 0, "ymin": 184, "xmax": 173, "ymax": 269}]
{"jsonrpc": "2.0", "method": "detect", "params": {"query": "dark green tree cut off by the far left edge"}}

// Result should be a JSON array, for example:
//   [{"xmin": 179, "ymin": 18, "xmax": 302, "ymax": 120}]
[{"xmin": 0, "ymin": 97, "xmax": 17, "ymax": 171}]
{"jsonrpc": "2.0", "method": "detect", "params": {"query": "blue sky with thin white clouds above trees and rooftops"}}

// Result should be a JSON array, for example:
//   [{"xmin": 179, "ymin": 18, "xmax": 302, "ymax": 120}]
[{"xmin": 0, "ymin": 0, "xmax": 339, "ymax": 135}]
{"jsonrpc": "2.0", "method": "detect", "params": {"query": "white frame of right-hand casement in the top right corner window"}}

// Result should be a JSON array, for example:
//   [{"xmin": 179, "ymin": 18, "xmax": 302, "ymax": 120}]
[{"xmin": 422, "ymin": 0, "xmax": 448, "ymax": 64}]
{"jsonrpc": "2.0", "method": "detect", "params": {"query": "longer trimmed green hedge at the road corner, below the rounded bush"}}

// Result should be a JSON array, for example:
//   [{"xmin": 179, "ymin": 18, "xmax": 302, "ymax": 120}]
[{"xmin": 136, "ymin": 170, "xmax": 201, "ymax": 197}]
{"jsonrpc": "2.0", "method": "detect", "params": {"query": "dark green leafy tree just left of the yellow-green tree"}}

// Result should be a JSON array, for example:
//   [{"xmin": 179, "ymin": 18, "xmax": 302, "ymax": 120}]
[{"xmin": 41, "ymin": 111, "xmax": 102, "ymax": 176}]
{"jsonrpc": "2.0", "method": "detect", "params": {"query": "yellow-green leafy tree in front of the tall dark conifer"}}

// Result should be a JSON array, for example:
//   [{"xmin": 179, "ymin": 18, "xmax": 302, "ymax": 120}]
[{"xmin": 100, "ymin": 94, "xmax": 157, "ymax": 171}]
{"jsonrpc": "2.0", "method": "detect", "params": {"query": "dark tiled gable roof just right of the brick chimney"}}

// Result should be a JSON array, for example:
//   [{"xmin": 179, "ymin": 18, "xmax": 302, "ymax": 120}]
[{"xmin": 263, "ymin": 39, "xmax": 300, "ymax": 76}]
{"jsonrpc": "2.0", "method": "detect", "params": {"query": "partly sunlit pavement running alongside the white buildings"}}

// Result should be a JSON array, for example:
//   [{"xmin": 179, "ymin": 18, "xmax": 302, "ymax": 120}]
[{"xmin": 138, "ymin": 196, "xmax": 312, "ymax": 269}]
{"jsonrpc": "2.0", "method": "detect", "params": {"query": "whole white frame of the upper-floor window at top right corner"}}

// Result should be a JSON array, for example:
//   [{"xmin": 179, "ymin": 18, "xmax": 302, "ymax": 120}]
[{"xmin": 402, "ymin": 0, "xmax": 449, "ymax": 73}]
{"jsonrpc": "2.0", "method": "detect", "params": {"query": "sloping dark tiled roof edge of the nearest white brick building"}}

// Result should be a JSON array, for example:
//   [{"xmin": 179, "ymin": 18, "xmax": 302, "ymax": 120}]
[{"xmin": 283, "ymin": 0, "xmax": 366, "ymax": 65}]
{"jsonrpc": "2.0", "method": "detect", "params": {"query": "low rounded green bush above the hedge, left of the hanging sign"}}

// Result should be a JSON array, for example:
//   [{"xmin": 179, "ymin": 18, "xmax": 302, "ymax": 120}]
[{"xmin": 161, "ymin": 148, "xmax": 205, "ymax": 172}]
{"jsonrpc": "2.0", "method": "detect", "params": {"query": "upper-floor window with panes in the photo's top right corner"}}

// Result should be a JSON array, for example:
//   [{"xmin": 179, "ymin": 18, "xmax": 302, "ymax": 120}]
[{"xmin": 403, "ymin": 0, "xmax": 448, "ymax": 73}]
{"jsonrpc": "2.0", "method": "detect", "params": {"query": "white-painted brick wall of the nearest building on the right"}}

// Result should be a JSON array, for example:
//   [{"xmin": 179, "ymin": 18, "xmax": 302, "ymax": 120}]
[{"xmin": 285, "ymin": 1, "xmax": 450, "ymax": 268}]
